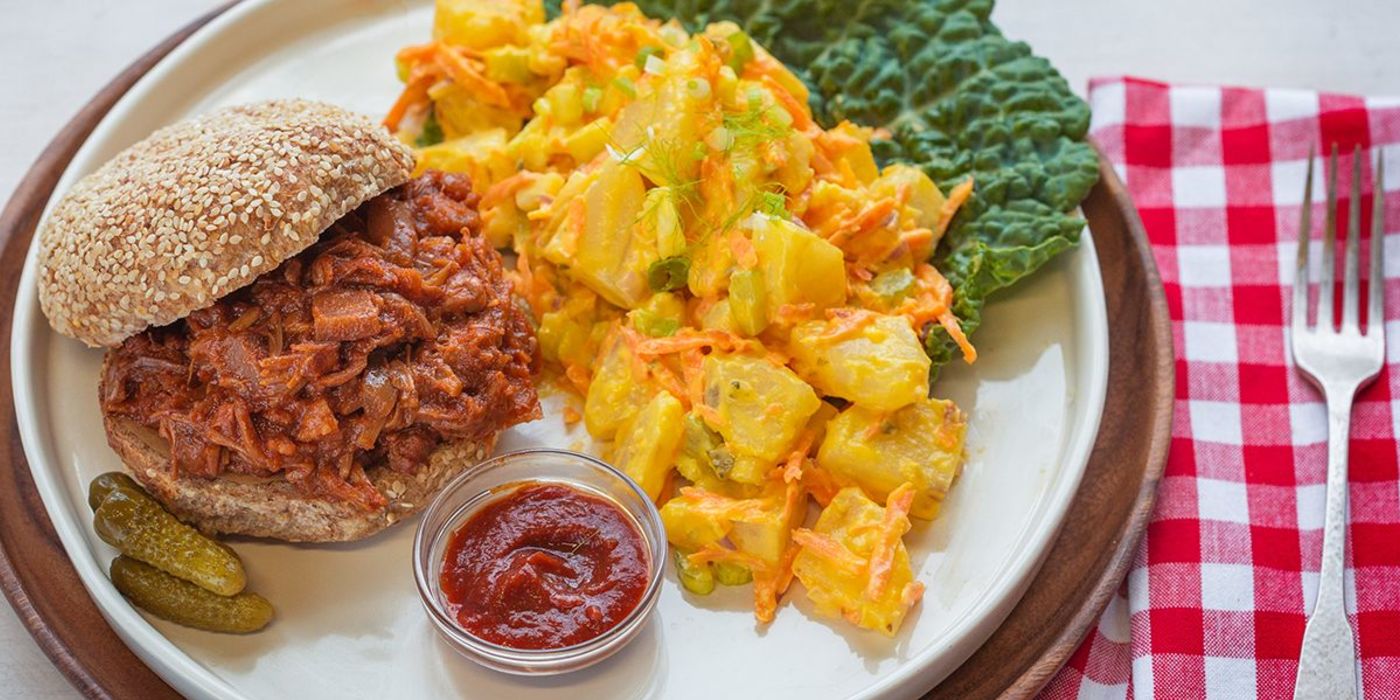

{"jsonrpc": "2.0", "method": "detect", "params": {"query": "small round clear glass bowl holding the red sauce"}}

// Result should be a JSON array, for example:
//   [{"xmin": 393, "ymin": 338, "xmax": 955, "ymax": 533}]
[{"xmin": 413, "ymin": 449, "xmax": 666, "ymax": 675}]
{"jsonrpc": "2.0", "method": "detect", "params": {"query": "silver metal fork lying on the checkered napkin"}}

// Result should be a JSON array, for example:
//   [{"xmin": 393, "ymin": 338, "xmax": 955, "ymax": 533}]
[{"xmin": 1291, "ymin": 146, "xmax": 1386, "ymax": 700}]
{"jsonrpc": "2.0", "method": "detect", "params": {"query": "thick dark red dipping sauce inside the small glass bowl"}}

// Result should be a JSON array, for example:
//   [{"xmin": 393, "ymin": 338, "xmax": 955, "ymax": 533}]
[{"xmin": 441, "ymin": 483, "xmax": 650, "ymax": 650}]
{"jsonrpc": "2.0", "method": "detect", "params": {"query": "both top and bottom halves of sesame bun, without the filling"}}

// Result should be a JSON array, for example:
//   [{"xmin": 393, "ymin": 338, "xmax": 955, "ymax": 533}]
[{"xmin": 63, "ymin": 99, "xmax": 509, "ymax": 542}]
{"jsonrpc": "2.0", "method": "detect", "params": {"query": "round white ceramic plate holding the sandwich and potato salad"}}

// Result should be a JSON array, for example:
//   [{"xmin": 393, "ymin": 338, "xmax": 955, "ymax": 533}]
[{"xmin": 11, "ymin": 0, "xmax": 1107, "ymax": 700}]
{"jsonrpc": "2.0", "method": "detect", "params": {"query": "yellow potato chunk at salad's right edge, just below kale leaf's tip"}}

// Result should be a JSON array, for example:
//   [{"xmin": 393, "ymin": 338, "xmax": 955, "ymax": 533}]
[{"xmin": 788, "ymin": 312, "xmax": 930, "ymax": 410}]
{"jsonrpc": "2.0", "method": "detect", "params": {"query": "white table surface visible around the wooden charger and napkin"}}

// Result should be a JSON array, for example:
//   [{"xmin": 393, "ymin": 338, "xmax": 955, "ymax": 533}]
[{"xmin": 0, "ymin": 0, "xmax": 1400, "ymax": 700}]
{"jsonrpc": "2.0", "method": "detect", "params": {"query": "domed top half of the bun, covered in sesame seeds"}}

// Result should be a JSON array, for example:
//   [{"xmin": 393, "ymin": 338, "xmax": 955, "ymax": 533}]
[{"xmin": 39, "ymin": 99, "xmax": 413, "ymax": 347}]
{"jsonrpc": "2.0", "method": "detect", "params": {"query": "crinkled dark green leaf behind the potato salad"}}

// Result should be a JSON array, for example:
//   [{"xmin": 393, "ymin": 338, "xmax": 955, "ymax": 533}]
[{"xmin": 550, "ymin": 0, "xmax": 1099, "ymax": 368}]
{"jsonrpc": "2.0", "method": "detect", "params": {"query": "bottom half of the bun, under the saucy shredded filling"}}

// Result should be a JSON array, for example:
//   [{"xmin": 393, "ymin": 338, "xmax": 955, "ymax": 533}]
[{"xmin": 102, "ymin": 416, "xmax": 496, "ymax": 542}]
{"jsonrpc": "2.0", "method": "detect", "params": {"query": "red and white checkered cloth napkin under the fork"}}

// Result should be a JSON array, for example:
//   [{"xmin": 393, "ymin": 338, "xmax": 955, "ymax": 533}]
[{"xmin": 1044, "ymin": 78, "xmax": 1400, "ymax": 700}]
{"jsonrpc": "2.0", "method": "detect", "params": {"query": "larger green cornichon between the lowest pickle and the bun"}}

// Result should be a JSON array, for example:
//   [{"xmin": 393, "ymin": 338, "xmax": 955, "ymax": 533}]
[{"xmin": 92, "ymin": 486, "xmax": 248, "ymax": 595}]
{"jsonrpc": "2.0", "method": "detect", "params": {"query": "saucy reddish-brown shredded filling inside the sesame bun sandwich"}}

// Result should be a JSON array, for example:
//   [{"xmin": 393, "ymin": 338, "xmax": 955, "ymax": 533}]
[{"xmin": 101, "ymin": 171, "xmax": 540, "ymax": 510}]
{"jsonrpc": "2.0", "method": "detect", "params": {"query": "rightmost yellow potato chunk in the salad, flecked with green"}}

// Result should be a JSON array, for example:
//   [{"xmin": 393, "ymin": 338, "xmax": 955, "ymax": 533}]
[{"xmin": 816, "ymin": 399, "xmax": 967, "ymax": 519}]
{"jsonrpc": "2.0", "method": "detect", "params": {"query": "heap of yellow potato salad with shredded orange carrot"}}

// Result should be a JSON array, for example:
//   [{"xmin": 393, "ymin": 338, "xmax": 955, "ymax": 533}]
[{"xmin": 385, "ymin": 0, "xmax": 976, "ymax": 634}]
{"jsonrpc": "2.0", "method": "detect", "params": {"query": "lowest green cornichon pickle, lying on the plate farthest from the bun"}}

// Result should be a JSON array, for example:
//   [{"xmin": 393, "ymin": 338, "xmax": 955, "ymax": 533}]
[{"xmin": 112, "ymin": 554, "xmax": 272, "ymax": 633}]
